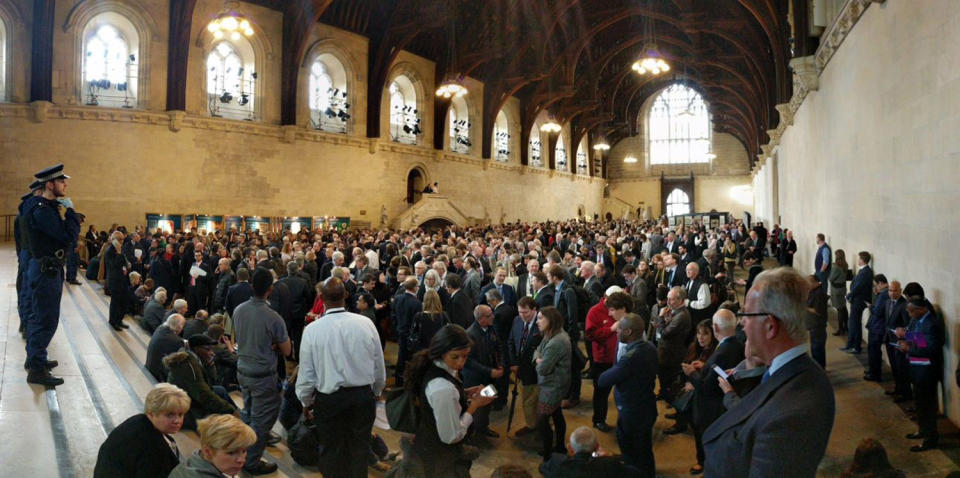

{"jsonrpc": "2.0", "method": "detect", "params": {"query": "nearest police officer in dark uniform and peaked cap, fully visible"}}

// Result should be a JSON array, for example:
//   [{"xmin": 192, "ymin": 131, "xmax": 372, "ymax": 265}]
[{"xmin": 23, "ymin": 164, "xmax": 84, "ymax": 386}]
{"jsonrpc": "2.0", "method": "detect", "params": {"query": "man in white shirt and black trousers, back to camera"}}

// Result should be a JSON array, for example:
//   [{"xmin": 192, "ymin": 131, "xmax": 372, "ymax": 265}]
[{"xmin": 297, "ymin": 277, "xmax": 386, "ymax": 478}]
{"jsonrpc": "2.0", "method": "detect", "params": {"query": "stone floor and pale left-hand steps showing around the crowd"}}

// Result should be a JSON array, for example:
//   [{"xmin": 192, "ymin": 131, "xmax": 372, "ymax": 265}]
[{"xmin": 0, "ymin": 248, "xmax": 960, "ymax": 477}]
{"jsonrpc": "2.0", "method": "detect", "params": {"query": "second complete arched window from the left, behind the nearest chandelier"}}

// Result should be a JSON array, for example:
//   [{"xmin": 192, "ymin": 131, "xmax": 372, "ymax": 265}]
[{"xmin": 207, "ymin": 38, "xmax": 257, "ymax": 121}]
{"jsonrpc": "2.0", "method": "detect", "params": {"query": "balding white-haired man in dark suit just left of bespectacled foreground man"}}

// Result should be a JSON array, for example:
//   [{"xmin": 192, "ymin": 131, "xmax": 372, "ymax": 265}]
[{"xmin": 683, "ymin": 309, "xmax": 744, "ymax": 471}]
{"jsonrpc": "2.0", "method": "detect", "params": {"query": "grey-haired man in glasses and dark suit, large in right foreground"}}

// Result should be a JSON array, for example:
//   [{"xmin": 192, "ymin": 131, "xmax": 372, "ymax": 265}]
[{"xmin": 703, "ymin": 267, "xmax": 836, "ymax": 478}]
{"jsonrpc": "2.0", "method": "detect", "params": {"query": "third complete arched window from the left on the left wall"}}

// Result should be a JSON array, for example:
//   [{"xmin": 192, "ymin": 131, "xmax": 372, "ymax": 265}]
[{"xmin": 308, "ymin": 53, "xmax": 350, "ymax": 133}]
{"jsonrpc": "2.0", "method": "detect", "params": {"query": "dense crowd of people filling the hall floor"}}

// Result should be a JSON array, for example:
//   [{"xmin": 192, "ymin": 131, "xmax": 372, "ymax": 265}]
[{"xmin": 13, "ymin": 168, "xmax": 943, "ymax": 477}]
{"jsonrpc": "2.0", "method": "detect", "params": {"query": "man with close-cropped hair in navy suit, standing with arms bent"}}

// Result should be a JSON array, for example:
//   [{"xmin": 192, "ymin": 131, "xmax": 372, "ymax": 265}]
[{"xmin": 597, "ymin": 314, "xmax": 657, "ymax": 477}]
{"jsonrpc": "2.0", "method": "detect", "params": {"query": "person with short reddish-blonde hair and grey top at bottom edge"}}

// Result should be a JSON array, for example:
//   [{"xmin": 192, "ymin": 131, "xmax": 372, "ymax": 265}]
[{"xmin": 170, "ymin": 415, "xmax": 257, "ymax": 478}]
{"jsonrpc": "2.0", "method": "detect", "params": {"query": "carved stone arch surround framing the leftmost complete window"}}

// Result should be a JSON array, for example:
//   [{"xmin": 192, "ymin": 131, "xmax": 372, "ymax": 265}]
[{"xmin": 63, "ymin": 0, "xmax": 161, "ymax": 109}]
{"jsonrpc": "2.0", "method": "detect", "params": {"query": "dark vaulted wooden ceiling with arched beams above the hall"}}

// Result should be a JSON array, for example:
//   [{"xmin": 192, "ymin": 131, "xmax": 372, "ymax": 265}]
[{"xmin": 249, "ymin": 0, "xmax": 812, "ymax": 168}]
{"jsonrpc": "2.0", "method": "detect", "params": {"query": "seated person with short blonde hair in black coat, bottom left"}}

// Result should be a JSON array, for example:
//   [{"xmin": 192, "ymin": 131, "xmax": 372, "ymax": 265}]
[{"xmin": 93, "ymin": 383, "xmax": 190, "ymax": 478}]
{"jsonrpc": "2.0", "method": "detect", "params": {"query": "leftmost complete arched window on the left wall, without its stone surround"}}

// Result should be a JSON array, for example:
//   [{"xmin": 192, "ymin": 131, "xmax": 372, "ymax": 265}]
[{"xmin": 80, "ymin": 12, "xmax": 140, "ymax": 108}]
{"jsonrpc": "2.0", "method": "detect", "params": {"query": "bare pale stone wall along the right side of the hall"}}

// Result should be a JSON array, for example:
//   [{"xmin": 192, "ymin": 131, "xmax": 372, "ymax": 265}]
[{"xmin": 758, "ymin": 0, "xmax": 960, "ymax": 423}]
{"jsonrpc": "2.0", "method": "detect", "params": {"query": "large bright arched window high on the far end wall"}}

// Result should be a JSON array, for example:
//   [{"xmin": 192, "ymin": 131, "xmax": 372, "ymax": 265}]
[{"xmin": 647, "ymin": 84, "xmax": 711, "ymax": 164}]
